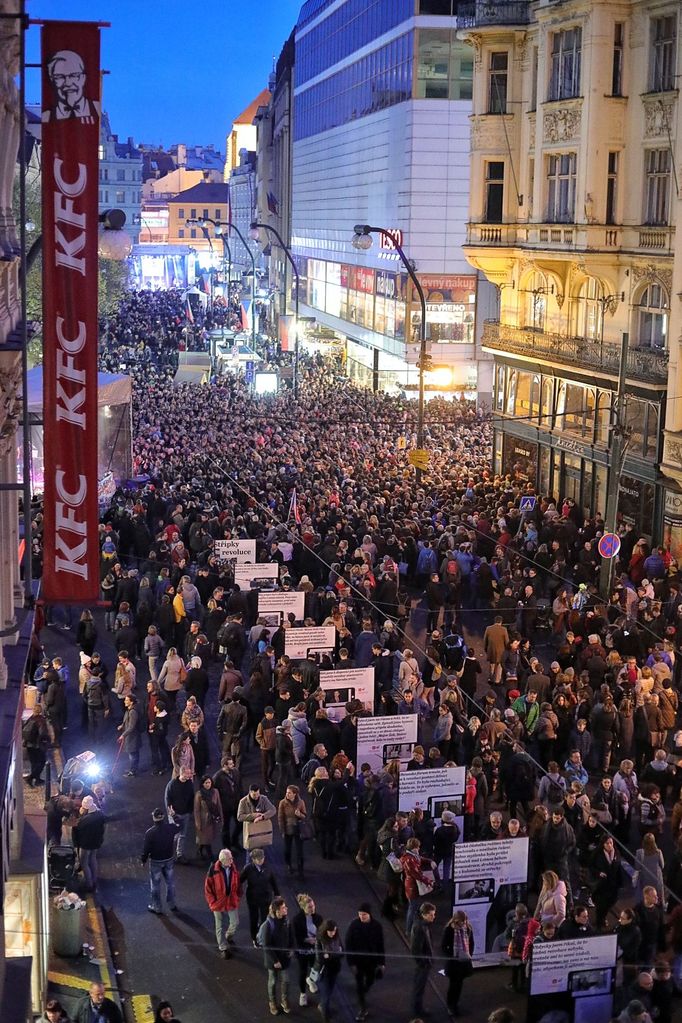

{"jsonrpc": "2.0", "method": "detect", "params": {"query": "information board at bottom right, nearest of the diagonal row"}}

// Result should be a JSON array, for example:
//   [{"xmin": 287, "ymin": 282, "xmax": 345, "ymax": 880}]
[{"xmin": 530, "ymin": 934, "xmax": 618, "ymax": 1023}]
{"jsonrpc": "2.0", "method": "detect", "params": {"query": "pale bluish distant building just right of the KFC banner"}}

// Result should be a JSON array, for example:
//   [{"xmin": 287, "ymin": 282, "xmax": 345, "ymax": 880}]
[{"xmin": 99, "ymin": 113, "xmax": 142, "ymax": 242}]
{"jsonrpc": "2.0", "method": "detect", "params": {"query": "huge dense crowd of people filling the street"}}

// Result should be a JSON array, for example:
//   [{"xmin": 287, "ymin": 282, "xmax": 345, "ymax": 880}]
[{"xmin": 25, "ymin": 294, "xmax": 682, "ymax": 1023}]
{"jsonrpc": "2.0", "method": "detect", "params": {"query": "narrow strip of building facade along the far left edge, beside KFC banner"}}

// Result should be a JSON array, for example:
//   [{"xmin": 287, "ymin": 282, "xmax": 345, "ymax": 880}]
[{"xmin": 0, "ymin": 0, "xmax": 48, "ymax": 1023}]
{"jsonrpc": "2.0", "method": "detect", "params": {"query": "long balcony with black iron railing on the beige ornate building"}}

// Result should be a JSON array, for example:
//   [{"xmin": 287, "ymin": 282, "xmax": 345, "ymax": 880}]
[{"xmin": 482, "ymin": 320, "xmax": 668, "ymax": 384}]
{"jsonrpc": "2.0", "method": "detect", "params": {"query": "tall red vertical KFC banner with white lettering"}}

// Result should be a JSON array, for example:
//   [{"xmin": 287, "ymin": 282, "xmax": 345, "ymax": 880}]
[{"xmin": 42, "ymin": 21, "xmax": 99, "ymax": 604}]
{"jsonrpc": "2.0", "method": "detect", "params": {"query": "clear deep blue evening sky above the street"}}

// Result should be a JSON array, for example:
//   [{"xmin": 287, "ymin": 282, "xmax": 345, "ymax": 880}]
[{"xmin": 27, "ymin": 0, "xmax": 303, "ymax": 151}]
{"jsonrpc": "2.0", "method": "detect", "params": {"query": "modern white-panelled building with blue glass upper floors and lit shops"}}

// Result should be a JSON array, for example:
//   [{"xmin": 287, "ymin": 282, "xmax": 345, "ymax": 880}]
[{"xmin": 291, "ymin": 0, "xmax": 491, "ymax": 400}]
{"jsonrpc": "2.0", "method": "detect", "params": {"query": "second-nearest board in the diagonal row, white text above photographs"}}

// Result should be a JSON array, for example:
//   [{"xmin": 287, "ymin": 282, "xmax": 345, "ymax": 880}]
[{"xmin": 452, "ymin": 838, "xmax": 529, "ymax": 966}]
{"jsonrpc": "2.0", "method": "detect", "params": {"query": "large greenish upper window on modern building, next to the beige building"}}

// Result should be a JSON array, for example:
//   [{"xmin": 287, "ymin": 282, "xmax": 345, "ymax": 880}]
[{"xmin": 416, "ymin": 29, "xmax": 473, "ymax": 99}]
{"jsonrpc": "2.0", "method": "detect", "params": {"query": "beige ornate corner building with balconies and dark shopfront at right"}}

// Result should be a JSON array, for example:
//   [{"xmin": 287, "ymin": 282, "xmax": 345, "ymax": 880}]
[{"xmin": 460, "ymin": 0, "xmax": 682, "ymax": 543}]
